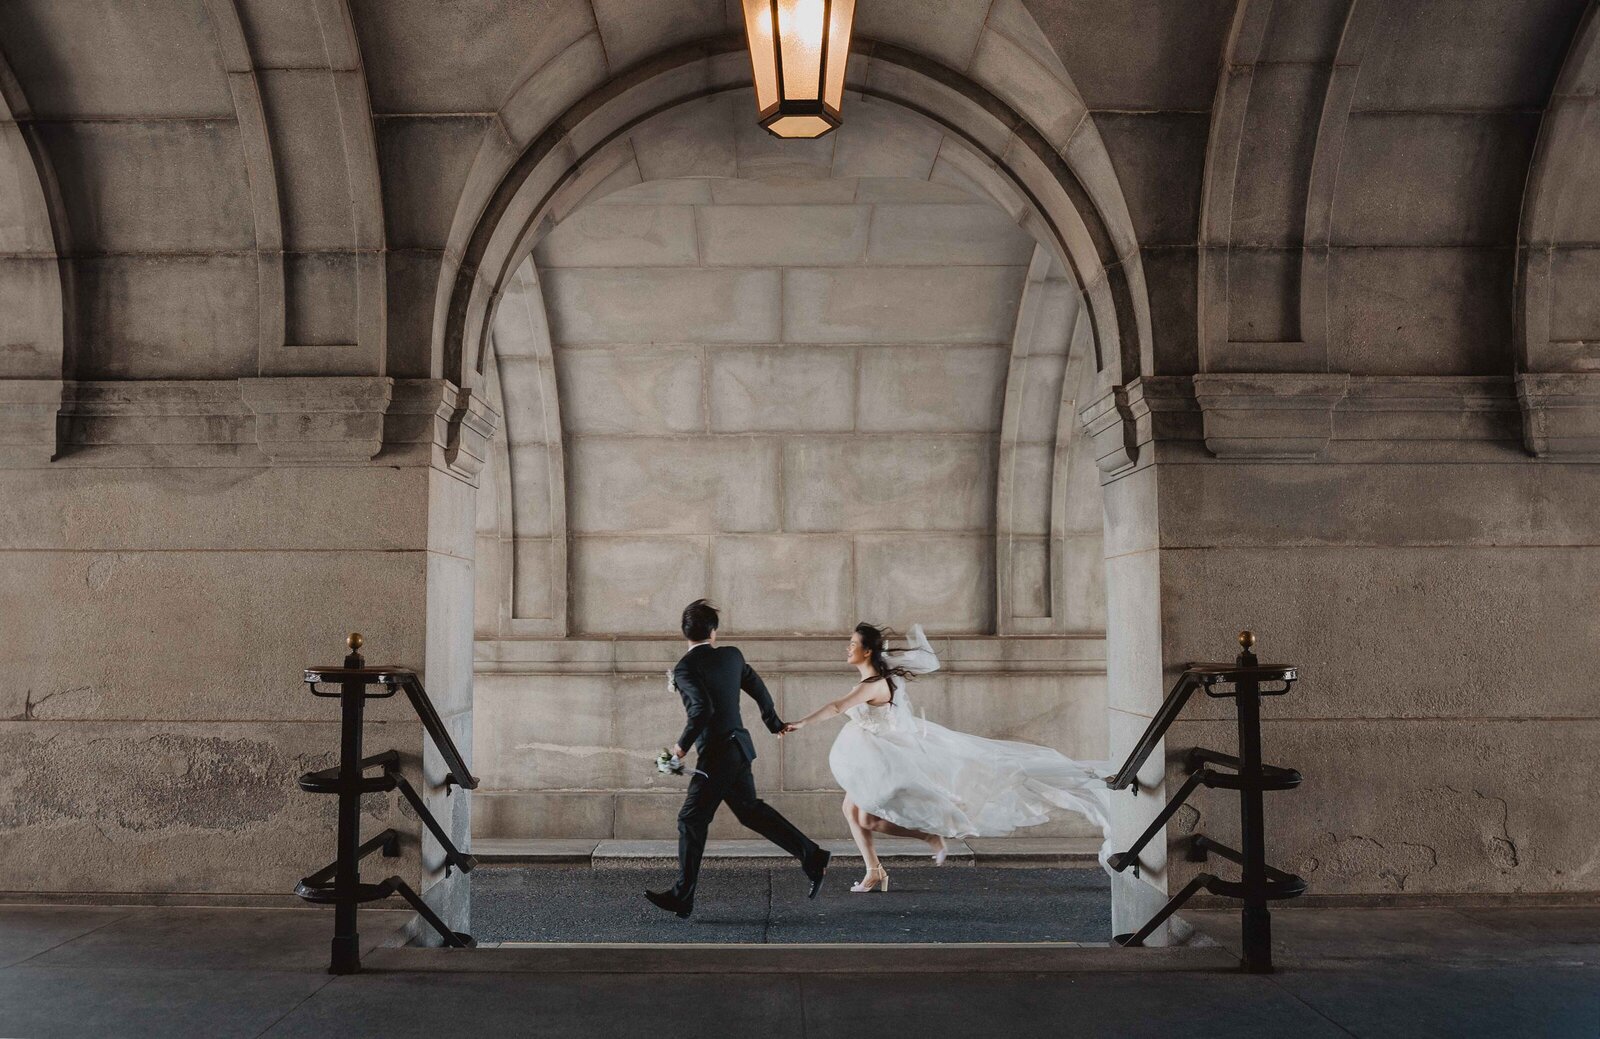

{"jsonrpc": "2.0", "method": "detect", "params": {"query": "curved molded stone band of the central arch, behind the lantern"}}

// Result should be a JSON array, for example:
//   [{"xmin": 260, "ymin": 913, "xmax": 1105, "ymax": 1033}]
[{"xmin": 434, "ymin": 37, "xmax": 1150, "ymax": 395}]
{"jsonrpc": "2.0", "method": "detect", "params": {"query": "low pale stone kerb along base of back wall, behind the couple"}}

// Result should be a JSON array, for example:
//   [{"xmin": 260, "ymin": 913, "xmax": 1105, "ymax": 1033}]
[{"xmin": 472, "ymin": 837, "xmax": 1099, "ymax": 869}]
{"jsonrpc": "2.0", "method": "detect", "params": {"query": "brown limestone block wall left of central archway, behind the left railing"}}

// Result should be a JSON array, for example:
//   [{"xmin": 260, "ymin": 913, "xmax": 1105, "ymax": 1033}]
[{"xmin": 0, "ymin": 0, "xmax": 493, "ymax": 922}]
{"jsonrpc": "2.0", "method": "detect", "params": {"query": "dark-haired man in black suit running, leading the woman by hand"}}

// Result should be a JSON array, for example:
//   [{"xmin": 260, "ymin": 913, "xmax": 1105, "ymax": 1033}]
[{"xmin": 645, "ymin": 599, "xmax": 830, "ymax": 917}]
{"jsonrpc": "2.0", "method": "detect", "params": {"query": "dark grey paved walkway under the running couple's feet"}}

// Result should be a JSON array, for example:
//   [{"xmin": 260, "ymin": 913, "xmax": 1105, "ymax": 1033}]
[{"xmin": 472, "ymin": 864, "xmax": 1110, "ymax": 943}]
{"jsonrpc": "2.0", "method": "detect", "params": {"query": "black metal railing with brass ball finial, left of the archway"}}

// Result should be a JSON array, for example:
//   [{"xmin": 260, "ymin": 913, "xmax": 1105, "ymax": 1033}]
[{"xmin": 294, "ymin": 634, "xmax": 478, "ymax": 973}]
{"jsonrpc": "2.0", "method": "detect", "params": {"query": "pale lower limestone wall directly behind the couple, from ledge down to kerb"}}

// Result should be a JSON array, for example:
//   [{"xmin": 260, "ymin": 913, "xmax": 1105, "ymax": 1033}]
[{"xmin": 472, "ymin": 632, "xmax": 1107, "ymax": 839}]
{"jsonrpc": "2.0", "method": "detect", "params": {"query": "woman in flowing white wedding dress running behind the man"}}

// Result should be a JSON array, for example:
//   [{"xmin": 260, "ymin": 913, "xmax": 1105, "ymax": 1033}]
[{"xmin": 784, "ymin": 624, "xmax": 1107, "ymax": 892}]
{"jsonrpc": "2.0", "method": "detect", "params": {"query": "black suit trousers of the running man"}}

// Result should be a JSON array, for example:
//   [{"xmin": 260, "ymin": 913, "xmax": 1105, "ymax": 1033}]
[{"xmin": 672, "ymin": 738, "xmax": 821, "ymax": 901}]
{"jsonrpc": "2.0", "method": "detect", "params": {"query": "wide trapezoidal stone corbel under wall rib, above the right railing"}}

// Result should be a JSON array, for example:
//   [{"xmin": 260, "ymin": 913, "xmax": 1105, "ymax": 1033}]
[{"xmin": 1194, "ymin": 373, "xmax": 1350, "ymax": 461}]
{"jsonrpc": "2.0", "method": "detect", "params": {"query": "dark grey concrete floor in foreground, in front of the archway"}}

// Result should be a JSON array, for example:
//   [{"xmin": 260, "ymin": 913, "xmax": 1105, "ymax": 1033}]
[{"xmin": 0, "ymin": 906, "xmax": 1600, "ymax": 1039}]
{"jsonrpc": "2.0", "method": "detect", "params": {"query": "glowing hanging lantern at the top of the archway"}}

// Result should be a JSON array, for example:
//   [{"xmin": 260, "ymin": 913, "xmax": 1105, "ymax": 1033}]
[{"xmin": 742, "ymin": 0, "xmax": 856, "ymax": 138}]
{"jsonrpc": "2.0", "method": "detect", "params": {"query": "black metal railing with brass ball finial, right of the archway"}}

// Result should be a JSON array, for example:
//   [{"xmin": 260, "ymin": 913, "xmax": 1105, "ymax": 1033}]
[{"xmin": 1106, "ymin": 631, "xmax": 1306, "ymax": 973}]
